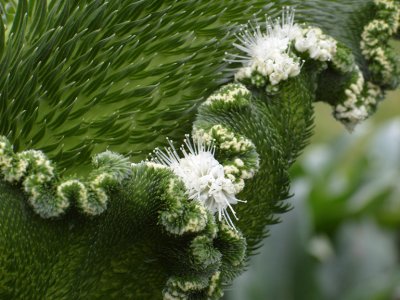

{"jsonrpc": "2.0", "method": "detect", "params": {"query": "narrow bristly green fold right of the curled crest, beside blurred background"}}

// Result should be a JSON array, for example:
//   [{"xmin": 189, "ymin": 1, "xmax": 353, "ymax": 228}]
[{"xmin": 196, "ymin": 65, "xmax": 316, "ymax": 251}]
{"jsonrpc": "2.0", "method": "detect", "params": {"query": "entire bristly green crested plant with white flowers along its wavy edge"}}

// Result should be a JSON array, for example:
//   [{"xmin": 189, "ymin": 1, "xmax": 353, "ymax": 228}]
[{"xmin": 0, "ymin": 0, "xmax": 400, "ymax": 299}]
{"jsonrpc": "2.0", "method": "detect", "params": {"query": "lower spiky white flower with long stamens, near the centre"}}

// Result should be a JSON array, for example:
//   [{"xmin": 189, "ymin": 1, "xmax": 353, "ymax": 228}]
[{"xmin": 153, "ymin": 136, "xmax": 245, "ymax": 228}]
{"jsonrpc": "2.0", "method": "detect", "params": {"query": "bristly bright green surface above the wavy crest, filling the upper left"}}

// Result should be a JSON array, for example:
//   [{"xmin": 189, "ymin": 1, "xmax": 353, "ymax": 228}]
[{"xmin": 0, "ymin": 0, "xmax": 382, "ymax": 172}]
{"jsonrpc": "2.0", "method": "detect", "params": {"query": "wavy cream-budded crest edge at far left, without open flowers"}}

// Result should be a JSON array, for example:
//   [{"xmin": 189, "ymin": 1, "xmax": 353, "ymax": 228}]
[{"xmin": 0, "ymin": 137, "xmax": 131, "ymax": 218}]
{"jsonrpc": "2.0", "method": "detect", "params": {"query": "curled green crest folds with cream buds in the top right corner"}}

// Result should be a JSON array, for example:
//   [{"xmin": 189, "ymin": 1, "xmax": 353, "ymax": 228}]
[{"xmin": 319, "ymin": 0, "xmax": 400, "ymax": 131}]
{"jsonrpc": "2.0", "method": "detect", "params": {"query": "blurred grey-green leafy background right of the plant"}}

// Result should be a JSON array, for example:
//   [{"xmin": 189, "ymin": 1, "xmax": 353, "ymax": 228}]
[{"xmin": 225, "ymin": 44, "xmax": 400, "ymax": 300}]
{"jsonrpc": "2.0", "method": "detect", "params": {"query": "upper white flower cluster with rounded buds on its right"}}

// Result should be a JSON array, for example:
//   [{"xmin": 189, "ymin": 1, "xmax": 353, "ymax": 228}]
[{"xmin": 227, "ymin": 7, "xmax": 336, "ymax": 86}]
